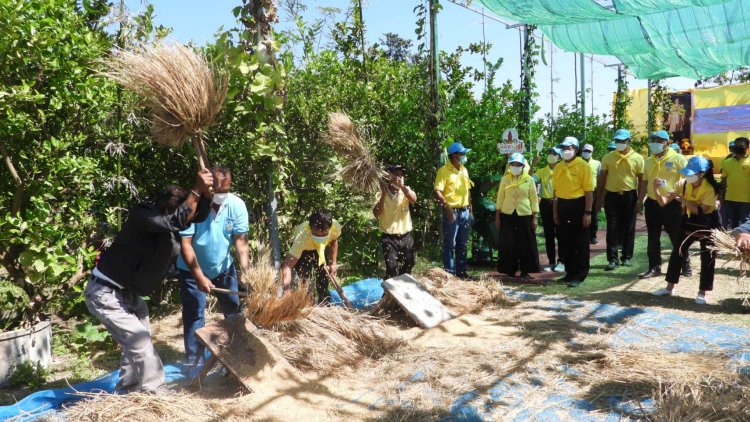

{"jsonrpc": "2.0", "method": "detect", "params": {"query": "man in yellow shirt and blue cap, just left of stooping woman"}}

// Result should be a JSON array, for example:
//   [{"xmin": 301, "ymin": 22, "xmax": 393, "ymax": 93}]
[{"xmin": 638, "ymin": 130, "xmax": 689, "ymax": 279}]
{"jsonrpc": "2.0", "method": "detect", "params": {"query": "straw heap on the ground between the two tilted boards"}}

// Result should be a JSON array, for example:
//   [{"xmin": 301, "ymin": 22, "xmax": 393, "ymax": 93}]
[{"xmin": 264, "ymin": 306, "xmax": 406, "ymax": 372}]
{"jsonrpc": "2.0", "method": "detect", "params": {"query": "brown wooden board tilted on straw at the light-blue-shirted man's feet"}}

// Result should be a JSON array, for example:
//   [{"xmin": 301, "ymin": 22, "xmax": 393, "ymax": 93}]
[{"xmin": 195, "ymin": 316, "xmax": 302, "ymax": 393}]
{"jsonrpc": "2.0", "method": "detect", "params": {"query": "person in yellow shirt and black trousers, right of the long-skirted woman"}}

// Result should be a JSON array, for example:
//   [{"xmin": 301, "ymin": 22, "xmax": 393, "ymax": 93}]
[{"xmin": 552, "ymin": 136, "xmax": 594, "ymax": 287}]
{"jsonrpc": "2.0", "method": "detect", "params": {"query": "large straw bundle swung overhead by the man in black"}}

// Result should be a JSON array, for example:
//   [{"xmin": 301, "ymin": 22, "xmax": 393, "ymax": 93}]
[{"xmin": 103, "ymin": 42, "xmax": 228, "ymax": 168}]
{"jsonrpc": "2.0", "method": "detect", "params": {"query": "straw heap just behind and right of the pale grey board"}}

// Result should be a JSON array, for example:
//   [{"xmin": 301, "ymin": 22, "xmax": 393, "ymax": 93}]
[{"xmin": 417, "ymin": 268, "xmax": 511, "ymax": 314}]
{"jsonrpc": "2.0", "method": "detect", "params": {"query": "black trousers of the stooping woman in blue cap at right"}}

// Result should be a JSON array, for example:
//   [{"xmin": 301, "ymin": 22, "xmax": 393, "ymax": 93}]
[{"xmin": 666, "ymin": 211, "xmax": 719, "ymax": 291}]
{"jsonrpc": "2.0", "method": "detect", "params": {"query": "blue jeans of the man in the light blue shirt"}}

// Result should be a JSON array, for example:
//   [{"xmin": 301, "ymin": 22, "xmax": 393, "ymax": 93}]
[{"xmin": 180, "ymin": 265, "xmax": 242, "ymax": 364}]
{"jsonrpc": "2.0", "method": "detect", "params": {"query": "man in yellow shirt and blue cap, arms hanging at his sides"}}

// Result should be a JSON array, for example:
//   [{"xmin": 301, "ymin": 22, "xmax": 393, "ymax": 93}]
[{"xmin": 594, "ymin": 129, "xmax": 644, "ymax": 271}]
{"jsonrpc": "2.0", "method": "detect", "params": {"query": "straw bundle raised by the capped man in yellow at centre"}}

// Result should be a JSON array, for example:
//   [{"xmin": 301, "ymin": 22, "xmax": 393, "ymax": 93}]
[{"xmin": 323, "ymin": 113, "xmax": 386, "ymax": 193}]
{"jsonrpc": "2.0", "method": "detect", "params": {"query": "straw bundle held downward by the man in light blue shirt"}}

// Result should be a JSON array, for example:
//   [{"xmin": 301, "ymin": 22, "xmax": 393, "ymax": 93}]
[{"xmin": 243, "ymin": 244, "xmax": 312, "ymax": 327}]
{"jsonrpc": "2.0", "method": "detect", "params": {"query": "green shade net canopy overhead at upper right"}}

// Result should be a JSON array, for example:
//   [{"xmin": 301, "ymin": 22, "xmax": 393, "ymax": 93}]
[{"xmin": 476, "ymin": 0, "xmax": 750, "ymax": 79}]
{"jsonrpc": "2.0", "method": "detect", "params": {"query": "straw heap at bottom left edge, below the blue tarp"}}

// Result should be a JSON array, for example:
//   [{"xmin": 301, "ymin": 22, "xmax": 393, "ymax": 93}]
[{"xmin": 64, "ymin": 392, "xmax": 220, "ymax": 422}]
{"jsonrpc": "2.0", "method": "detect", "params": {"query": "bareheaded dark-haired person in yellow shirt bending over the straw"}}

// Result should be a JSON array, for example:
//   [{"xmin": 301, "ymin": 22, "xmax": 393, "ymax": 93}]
[{"xmin": 281, "ymin": 210, "xmax": 341, "ymax": 304}]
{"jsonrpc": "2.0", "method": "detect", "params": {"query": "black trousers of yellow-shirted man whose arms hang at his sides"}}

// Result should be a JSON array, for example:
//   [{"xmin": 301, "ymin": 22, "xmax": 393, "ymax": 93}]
[{"xmin": 604, "ymin": 190, "xmax": 638, "ymax": 265}]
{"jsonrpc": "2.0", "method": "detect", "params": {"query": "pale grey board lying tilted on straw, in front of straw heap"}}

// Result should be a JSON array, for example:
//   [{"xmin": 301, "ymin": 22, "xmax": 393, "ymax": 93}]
[{"xmin": 383, "ymin": 274, "xmax": 455, "ymax": 328}]
